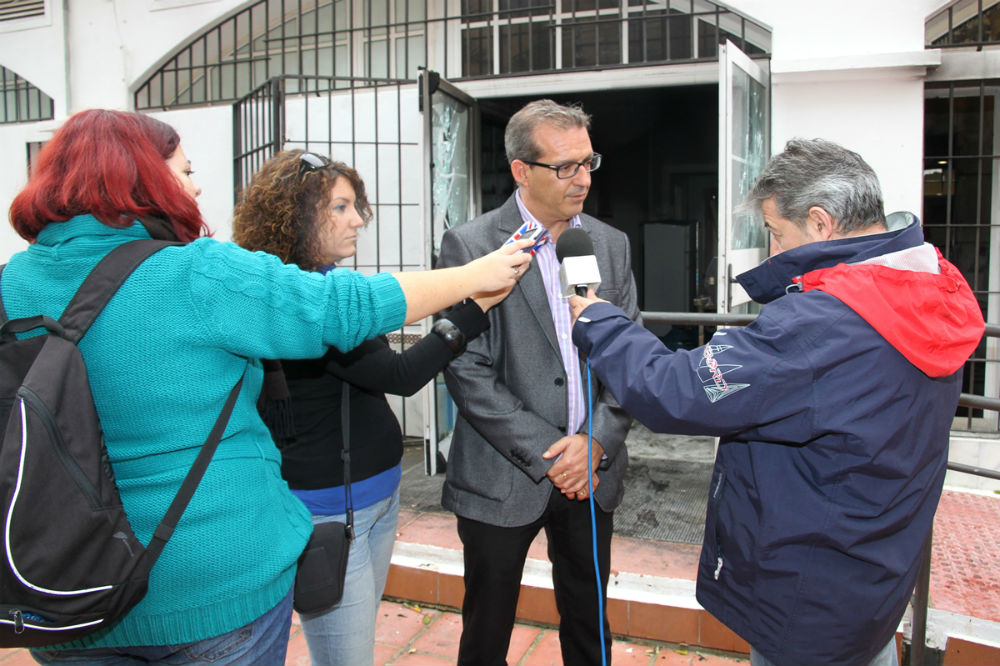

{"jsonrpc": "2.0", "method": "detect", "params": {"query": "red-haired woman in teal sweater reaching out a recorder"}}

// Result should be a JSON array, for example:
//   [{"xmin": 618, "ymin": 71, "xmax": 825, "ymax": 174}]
[{"xmin": 0, "ymin": 110, "xmax": 530, "ymax": 664}]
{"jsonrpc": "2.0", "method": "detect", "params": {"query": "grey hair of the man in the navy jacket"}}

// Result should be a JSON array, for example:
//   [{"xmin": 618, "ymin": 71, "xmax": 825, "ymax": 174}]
[{"xmin": 741, "ymin": 139, "xmax": 885, "ymax": 233}]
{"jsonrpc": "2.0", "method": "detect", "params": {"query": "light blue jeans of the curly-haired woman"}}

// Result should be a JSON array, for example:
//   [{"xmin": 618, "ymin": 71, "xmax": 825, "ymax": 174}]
[{"xmin": 300, "ymin": 488, "xmax": 399, "ymax": 666}]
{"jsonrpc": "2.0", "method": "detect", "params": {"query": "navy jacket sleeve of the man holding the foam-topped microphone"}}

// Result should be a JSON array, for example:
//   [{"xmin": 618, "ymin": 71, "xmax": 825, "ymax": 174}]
[{"xmin": 573, "ymin": 297, "xmax": 815, "ymax": 442}]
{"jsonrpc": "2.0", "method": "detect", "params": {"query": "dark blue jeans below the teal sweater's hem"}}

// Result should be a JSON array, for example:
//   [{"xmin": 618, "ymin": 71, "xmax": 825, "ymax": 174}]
[{"xmin": 31, "ymin": 590, "xmax": 292, "ymax": 666}]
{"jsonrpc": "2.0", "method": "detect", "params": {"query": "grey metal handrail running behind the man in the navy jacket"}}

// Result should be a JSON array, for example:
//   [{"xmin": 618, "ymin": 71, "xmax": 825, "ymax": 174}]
[{"xmin": 640, "ymin": 312, "xmax": 1000, "ymax": 666}]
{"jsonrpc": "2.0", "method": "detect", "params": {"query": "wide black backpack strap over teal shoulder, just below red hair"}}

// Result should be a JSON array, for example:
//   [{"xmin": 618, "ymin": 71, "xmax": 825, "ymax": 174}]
[{"xmin": 59, "ymin": 238, "xmax": 183, "ymax": 344}]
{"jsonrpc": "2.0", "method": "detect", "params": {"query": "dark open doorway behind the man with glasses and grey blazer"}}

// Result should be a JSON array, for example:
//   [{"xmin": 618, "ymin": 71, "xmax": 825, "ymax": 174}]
[{"xmin": 479, "ymin": 85, "xmax": 719, "ymax": 349}]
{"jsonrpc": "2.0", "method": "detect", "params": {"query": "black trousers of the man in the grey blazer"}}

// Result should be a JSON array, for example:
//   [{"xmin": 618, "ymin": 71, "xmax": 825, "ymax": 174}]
[{"xmin": 458, "ymin": 488, "xmax": 614, "ymax": 666}]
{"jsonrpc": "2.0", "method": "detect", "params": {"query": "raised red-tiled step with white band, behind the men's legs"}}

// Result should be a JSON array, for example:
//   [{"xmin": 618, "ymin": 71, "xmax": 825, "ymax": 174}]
[{"xmin": 376, "ymin": 482, "xmax": 1000, "ymax": 666}]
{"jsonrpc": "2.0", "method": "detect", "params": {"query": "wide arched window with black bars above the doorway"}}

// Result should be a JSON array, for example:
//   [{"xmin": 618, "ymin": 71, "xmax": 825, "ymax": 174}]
[{"xmin": 135, "ymin": 0, "xmax": 770, "ymax": 109}]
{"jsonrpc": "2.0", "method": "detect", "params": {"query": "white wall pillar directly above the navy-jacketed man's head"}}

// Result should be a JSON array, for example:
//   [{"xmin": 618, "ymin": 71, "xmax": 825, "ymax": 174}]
[{"xmin": 727, "ymin": 0, "xmax": 946, "ymax": 213}]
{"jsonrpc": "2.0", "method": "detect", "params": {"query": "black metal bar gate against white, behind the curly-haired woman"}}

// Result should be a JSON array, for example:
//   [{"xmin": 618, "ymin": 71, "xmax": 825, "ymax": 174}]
[{"xmin": 233, "ymin": 76, "xmax": 429, "ymax": 439}]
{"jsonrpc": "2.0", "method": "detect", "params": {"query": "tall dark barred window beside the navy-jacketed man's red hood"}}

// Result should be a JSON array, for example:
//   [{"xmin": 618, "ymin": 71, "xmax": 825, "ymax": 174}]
[{"xmin": 922, "ymin": 80, "xmax": 1000, "ymax": 431}]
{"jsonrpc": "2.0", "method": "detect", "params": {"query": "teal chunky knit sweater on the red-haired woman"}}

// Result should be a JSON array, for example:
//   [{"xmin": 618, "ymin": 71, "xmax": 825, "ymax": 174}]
[{"xmin": 0, "ymin": 215, "xmax": 406, "ymax": 647}]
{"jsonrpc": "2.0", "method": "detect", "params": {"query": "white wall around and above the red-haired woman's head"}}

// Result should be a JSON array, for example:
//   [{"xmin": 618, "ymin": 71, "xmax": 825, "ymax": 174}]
[{"xmin": 0, "ymin": 0, "xmax": 246, "ymax": 255}]
